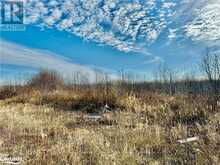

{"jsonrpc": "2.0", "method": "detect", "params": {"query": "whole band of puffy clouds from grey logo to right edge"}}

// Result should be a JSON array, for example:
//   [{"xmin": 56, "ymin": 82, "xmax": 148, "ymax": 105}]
[{"xmin": 22, "ymin": 0, "xmax": 220, "ymax": 53}]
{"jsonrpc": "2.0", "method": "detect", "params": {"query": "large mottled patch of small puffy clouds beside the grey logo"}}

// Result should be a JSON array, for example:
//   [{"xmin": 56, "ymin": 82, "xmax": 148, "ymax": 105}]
[{"xmin": 26, "ymin": 0, "xmax": 175, "ymax": 52}]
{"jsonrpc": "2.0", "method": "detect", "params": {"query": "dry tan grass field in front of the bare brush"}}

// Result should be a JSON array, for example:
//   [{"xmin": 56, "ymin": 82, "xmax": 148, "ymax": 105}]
[{"xmin": 0, "ymin": 93, "xmax": 220, "ymax": 165}]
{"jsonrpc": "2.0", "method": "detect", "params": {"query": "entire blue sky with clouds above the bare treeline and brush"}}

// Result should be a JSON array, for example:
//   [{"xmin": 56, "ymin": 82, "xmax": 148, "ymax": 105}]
[{"xmin": 0, "ymin": 0, "xmax": 220, "ymax": 83}]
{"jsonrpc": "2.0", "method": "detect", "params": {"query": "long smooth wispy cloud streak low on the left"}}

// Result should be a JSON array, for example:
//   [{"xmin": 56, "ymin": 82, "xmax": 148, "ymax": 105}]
[{"xmin": 0, "ymin": 40, "xmax": 98, "ymax": 81}]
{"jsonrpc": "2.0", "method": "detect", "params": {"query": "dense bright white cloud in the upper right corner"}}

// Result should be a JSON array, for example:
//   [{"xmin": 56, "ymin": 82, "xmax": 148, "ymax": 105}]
[{"xmin": 185, "ymin": 0, "xmax": 220, "ymax": 41}]
